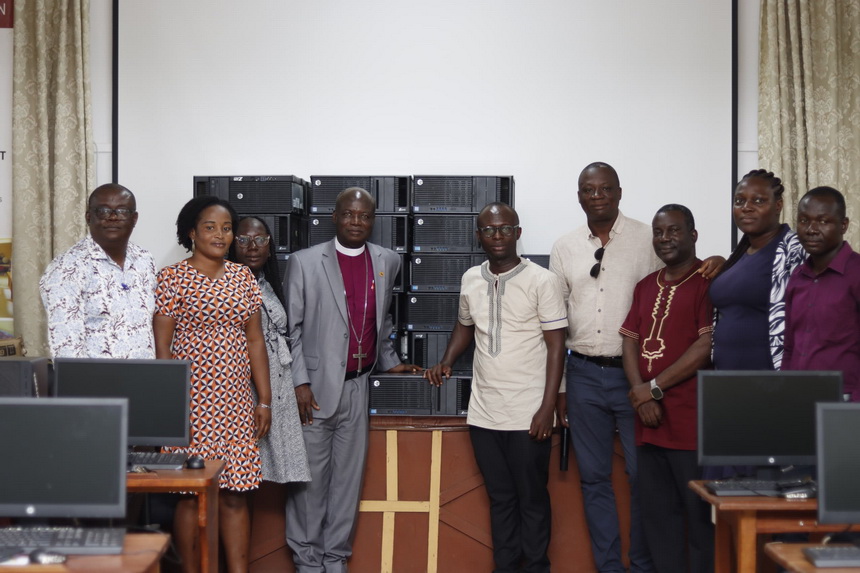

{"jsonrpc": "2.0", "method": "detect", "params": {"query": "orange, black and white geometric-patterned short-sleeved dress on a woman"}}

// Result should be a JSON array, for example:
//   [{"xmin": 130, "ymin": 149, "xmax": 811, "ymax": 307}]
[{"xmin": 155, "ymin": 261, "xmax": 262, "ymax": 491}]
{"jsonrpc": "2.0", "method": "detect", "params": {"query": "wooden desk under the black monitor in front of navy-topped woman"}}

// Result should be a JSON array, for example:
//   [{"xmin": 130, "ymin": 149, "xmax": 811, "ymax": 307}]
[{"xmin": 690, "ymin": 481, "xmax": 857, "ymax": 573}]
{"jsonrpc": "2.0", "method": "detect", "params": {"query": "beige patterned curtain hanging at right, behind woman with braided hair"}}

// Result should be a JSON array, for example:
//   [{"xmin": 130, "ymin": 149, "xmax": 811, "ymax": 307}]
[{"xmin": 758, "ymin": 0, "xmax": 860, "ymax": 245}]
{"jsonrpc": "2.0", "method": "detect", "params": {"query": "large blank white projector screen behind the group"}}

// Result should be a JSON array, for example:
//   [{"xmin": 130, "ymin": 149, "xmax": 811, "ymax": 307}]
[{"xmin": 114, "ymin": 0, "xmax": 734, "ymax": 267}]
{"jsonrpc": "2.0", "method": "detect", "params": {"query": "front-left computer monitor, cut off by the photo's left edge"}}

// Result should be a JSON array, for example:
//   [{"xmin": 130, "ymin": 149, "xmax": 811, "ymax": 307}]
[{"xmin": 0, "ymin": 397, "xmax": 128, "ymax": 518}]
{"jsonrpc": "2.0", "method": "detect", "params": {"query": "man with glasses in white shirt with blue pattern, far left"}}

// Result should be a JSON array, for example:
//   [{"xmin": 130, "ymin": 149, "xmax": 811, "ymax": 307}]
[{"xmin": 39, "ymin": 183, "xmax": 155, "ymax": 358}]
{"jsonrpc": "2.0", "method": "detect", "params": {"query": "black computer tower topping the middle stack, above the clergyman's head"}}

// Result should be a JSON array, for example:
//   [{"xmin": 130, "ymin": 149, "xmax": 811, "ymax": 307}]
[{"xmin": 308, "ymin": 175, "xmax": 412, "ymax": 214}]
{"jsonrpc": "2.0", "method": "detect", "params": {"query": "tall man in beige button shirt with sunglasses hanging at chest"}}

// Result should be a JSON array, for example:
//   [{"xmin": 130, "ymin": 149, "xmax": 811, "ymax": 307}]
[{"xmin": 550, "ymin": 163, "xmax": 662, "ymax": 573}]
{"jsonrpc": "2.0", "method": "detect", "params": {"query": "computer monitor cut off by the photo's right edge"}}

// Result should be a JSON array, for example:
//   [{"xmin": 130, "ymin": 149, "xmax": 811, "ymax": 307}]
[{"xmin": 816, "ymin": 403, "xmax": 860, "ymax": 524}]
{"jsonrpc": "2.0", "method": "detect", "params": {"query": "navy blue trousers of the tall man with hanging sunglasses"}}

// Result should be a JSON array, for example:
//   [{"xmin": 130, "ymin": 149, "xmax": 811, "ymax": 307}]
[{"xmin": 567, "ymin": 356, "xmax": 654, "ymax": 573}]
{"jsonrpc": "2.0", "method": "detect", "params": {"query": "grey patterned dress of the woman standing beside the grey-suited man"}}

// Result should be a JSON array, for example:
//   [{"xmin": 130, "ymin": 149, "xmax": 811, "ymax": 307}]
[{"xmin": 252, "ymin": 278, "xmax": 311, "ymax": 483}]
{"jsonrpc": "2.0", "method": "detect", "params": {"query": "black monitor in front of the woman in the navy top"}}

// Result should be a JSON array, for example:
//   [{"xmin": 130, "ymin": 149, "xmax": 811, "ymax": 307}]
[{"xmin": 698, "ymin": 370, "xmax": 842, "ymax": 467}]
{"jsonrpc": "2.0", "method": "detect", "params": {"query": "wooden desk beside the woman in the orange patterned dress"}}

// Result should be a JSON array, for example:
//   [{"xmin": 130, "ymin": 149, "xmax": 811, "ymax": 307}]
[{"xmin": 126, "ymin": 460, "xmax": 224, "ymax": 573}]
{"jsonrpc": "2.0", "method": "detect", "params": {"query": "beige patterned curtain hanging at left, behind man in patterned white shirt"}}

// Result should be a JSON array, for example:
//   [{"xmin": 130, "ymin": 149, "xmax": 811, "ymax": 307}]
[{"xmin": 12, "ymin": 0, "xmax": 95, "ymax": 356}]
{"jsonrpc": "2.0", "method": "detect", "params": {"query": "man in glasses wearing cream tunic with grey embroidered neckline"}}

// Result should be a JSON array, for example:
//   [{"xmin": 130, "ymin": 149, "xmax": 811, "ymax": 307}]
[{"xmin": 426, "ymin": 203, "xmax": 567, "ymax": 573}]
